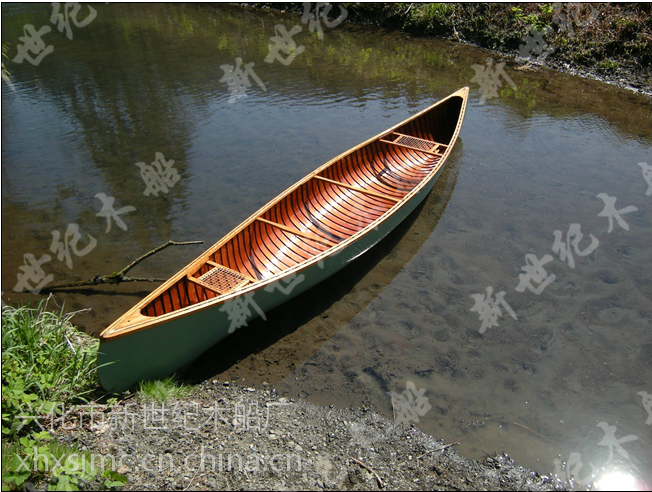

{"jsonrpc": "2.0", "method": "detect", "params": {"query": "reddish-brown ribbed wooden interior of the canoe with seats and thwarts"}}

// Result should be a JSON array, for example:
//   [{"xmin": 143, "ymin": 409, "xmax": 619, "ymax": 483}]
[{"xmin": 129, "ymin": 96, "xmax": 464, "ymax": 317}]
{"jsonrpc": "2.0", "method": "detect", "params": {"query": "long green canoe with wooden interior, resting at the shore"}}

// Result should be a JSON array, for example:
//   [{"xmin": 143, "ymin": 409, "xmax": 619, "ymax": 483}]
[{"xmin": 98, "ymin": 87, "xmax": 468, "ymax": 391}]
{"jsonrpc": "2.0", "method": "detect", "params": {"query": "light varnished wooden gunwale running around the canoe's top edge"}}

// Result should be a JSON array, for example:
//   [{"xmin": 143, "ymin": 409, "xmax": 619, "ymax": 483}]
[{"xmin": 100, "ymin": 87, "xmax": 469, "ymax": 341}]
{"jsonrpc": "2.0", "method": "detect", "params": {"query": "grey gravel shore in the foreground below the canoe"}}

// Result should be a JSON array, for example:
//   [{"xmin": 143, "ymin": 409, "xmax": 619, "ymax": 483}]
[{"xmin": 55, "ymin": 380, "xmax": 567, "ymax": 490}]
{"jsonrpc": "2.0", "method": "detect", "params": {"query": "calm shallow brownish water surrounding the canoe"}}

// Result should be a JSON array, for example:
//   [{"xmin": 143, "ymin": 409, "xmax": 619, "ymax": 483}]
[{"xmin": 2, "ymin": 4, "xmax": 652, "ymax": 488}]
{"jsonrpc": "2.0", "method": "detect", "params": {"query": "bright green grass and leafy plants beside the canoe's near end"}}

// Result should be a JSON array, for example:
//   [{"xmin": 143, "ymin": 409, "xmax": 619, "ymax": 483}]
[{"xmin": 2, "ymin": 298, "xmax": 126, "ymax": 490}]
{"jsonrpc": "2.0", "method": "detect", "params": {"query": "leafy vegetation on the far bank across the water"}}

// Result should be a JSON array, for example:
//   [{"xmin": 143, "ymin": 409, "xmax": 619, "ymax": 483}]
[{"xmin": 248, "ymin": 2, "xmax": 652, "ymax": 86}]
